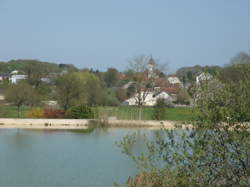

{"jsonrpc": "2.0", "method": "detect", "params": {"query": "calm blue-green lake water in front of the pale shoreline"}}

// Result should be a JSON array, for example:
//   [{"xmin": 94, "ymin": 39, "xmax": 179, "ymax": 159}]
[{"xmin": 0, "ymin": 129, "xmax": 157, "ymax": 187}]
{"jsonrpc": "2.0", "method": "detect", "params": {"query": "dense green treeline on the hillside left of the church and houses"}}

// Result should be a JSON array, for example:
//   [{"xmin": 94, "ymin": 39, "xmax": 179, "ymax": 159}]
[{"xmin": 0, "ymin": 60, "xmax": 135, "ymax": 116}]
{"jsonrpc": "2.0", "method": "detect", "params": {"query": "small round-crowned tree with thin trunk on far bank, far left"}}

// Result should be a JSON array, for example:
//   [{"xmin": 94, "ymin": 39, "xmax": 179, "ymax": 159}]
[{"xmin": 5, "ymin": 81, "xmax": 39, "ymax": 117}]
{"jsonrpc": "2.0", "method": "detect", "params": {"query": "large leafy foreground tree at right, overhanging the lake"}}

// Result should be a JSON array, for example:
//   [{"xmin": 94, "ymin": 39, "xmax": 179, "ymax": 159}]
[{"xmin": 120, "ymin": 66, "xmax": 250, "ymax": 187}]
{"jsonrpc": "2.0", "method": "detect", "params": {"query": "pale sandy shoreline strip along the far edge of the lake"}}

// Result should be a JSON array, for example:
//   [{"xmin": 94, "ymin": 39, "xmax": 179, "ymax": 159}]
[{"xmin": 0, "ymin": 118, "xmax": 192, "ymax": 130}]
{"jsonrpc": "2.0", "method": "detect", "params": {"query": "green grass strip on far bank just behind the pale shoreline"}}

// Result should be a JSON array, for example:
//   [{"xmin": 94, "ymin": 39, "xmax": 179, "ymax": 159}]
[{"xmin": 0, "ymin": 106, "xmax": 195, "ymax": 121}]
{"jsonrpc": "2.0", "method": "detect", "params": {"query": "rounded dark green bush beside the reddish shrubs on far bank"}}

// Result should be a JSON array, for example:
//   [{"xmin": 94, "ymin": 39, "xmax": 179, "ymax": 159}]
[{"xmin": 68, "ymin": 105, "xmax": 94, "ymax": 119}]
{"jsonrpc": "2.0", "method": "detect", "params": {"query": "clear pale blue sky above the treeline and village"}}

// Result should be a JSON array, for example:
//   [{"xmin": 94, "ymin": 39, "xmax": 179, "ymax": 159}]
[{"xmin": 0, "ymin": 0, "xmax": 250, "ymax": 72}]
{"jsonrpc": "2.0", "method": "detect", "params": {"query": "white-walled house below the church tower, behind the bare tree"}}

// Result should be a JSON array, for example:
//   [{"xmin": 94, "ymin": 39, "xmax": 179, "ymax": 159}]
[{"xmin": 124, "ymin": 91, "xmax": 173, "ymax": 106}]
